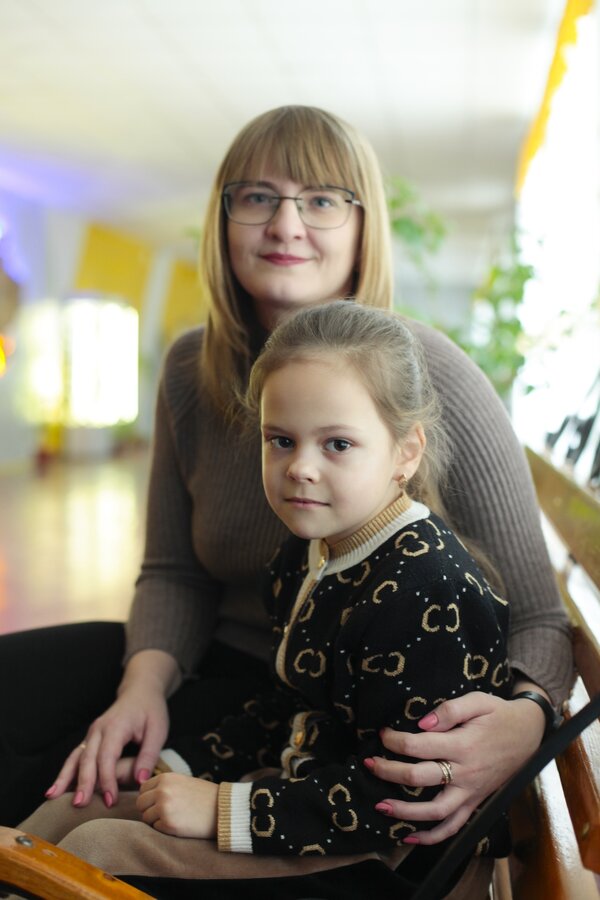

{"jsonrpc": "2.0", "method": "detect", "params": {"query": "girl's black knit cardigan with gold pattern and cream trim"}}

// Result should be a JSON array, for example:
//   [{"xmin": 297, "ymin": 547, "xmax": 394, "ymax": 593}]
[{"xmin": 164, "ymin": 507, "xmax": 510, "ymax": 856}]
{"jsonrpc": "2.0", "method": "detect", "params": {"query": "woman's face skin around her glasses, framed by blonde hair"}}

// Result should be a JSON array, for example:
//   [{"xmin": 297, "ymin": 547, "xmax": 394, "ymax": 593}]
[{"xmin": 227, "ymin": 175, "xmax": 362, "ymax": 330}]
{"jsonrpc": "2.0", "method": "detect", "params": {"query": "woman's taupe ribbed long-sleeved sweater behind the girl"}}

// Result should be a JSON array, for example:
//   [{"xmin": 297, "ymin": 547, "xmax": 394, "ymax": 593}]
[{"xmin": 127, "ymin": 323, "xmax": 572, "ymax": 702}]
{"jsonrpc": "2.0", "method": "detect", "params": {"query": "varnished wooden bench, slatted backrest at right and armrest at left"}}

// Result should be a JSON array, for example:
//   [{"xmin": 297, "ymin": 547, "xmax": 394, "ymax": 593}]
[{"xmin": 0, "ymin": 451, "xmax": 600, "ymax": 900}]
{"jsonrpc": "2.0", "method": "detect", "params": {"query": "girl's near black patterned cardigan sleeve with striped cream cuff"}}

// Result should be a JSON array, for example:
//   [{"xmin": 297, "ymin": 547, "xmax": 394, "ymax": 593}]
[{"xmin": 218, "ymin": 577, "xmax": 509, "ymax": 856}]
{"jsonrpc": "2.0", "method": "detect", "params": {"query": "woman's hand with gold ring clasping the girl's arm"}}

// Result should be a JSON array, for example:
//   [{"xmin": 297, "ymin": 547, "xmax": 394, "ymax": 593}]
[{"xmin": 369, "ymin": 685, "xmax": 545, "ymax": 844}]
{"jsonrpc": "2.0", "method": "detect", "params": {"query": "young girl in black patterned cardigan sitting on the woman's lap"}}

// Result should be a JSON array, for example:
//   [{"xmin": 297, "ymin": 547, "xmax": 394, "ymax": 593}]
[{"xmin": 23, "ymin": 301, "xmax": 511, "ymax": 897}]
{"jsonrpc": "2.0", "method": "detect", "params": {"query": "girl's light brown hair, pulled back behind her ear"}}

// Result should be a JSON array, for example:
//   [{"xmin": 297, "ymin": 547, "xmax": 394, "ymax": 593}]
[{"xmin": 246, "ymin": 300, "xmax": 450, "ymax": 515}]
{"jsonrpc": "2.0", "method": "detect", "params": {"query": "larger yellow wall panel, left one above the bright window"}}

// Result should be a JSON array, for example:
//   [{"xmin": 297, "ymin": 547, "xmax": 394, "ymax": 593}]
[{"xmin": 75, "ymin": 223, "xmax": 152, "ymax": 311}]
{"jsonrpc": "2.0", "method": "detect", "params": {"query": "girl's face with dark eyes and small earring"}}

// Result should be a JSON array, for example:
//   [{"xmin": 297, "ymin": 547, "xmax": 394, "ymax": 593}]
[{"xmin": 261, "ymin": 356, "xmax": 422, "ymax": 544}]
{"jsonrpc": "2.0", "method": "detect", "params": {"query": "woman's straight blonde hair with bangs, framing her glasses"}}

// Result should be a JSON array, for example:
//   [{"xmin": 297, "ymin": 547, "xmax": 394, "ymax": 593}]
[{"xmin": 199, "ymin": 106, "xmax": 393, "ymax": 418}]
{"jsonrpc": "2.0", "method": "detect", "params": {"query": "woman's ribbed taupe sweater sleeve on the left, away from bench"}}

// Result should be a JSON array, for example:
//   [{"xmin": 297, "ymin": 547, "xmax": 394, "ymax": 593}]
[{"xmin": 125, "ymin": 340, "xmax": 219, "ymax": 674}]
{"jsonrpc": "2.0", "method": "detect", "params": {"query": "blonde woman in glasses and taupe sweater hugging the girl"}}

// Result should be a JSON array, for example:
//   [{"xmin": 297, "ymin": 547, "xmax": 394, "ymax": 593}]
[{"xmin": 0, "ymin": 107, "xmax": 572, "ymax": 844}]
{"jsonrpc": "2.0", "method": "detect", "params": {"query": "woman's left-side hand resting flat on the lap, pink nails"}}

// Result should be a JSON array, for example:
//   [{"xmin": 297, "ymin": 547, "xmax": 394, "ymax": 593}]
[{"xmin": 46, "ymin": 650, "xmax": 179, "ymax": 807}]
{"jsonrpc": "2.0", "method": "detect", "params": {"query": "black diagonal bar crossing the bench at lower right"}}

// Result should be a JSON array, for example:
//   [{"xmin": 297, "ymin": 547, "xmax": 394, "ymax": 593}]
[{"xmin": 411, "ymin": 694, "xmax": 600, "ymax": 900}]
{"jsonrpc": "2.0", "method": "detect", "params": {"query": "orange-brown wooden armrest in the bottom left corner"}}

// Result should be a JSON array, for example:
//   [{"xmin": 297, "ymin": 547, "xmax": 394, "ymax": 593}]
[{"xmin": 0, "ymin": 826, "xmax": 149, "ymax": 900}]
